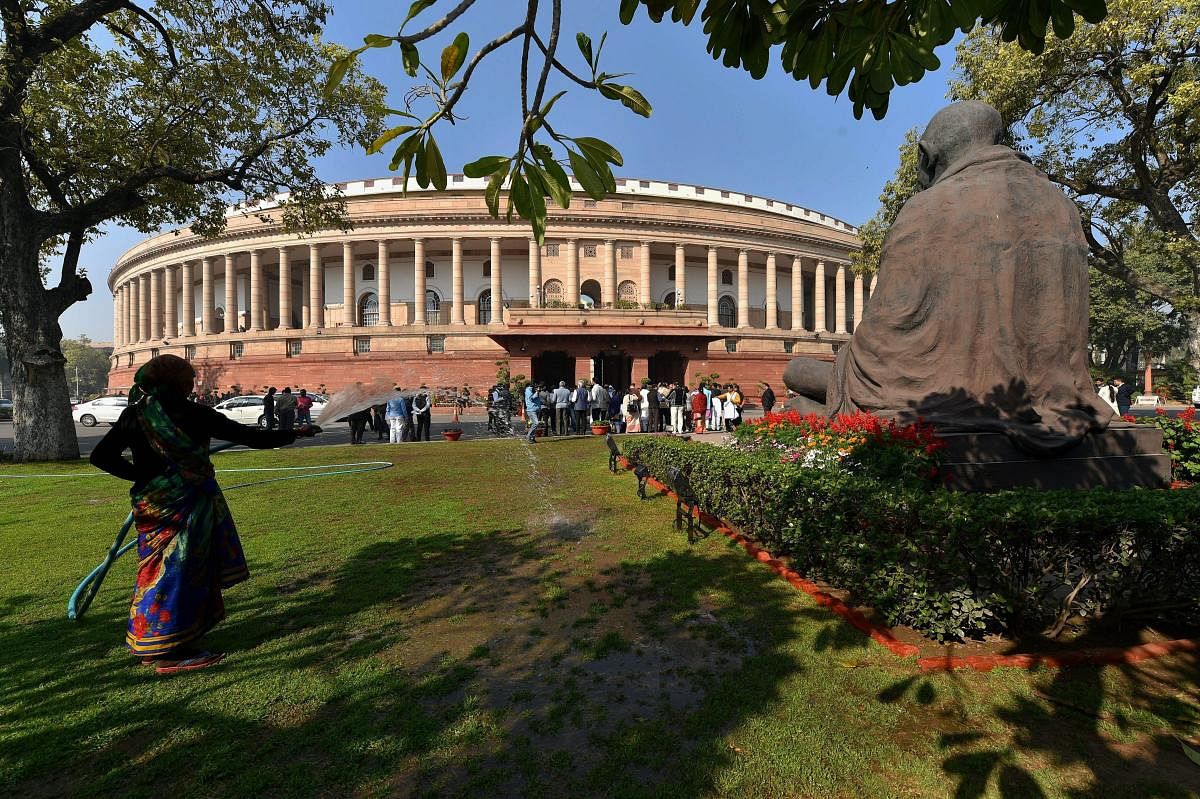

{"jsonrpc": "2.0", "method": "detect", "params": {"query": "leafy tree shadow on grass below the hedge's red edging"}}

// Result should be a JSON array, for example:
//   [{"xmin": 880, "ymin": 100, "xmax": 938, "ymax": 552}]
[{"xmin": 877, "ymin": 623, "xmax": 1200, "ymax": 799}]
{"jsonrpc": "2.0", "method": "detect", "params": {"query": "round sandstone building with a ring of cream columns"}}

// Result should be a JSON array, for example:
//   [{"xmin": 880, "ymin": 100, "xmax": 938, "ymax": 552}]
[{"xmin": 108, "ymin": 175, "xmax": 869, "ymax": 397}]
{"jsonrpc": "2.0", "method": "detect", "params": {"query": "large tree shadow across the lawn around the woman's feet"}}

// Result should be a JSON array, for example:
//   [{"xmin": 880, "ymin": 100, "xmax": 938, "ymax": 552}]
[{"xmin": 0, "ymin": 513, "xmax": 800, "ymax": 797}]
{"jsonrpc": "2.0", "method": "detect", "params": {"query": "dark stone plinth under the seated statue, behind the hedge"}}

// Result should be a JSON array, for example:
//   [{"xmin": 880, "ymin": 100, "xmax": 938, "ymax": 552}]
[{"xmin": 940, "ymin": 422, "xmax": 1171, "ymax": 491}]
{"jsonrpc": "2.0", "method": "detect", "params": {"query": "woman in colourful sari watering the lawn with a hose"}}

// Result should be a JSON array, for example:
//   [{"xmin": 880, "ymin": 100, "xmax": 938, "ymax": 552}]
[{"xmin": 91, "ymin": 355, "xmax": 320, "ymax": 674}]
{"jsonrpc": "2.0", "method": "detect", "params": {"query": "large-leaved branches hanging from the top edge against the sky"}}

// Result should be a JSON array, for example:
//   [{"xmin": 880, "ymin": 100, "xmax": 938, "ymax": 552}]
[{"xmin": 326, "ymin": 0, "xmax": 1105, "ymax": 242}]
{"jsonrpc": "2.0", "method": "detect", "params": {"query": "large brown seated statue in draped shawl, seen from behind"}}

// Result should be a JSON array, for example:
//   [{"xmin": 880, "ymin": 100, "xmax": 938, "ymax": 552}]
[{"xmin": 784, "ymin": 102, "xmax": 1112, "ymax": 455}]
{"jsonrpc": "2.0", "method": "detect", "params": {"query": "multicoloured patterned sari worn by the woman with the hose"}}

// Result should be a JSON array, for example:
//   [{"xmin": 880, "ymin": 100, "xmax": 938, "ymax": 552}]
[{"xmin": 125, "ymin": 373, "xmax": 250, "ymax": 657}]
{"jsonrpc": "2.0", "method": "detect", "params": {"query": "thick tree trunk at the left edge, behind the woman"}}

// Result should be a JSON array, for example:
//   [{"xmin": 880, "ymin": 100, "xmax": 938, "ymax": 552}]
[{"xmin": 0, "ymin": 226, "xmax": 79, "ymax": 461}]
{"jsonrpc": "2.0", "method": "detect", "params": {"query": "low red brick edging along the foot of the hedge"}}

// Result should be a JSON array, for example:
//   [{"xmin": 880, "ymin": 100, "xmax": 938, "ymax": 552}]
[{"xmin": 619, "ymin": 456, "xmax": 1200, "ymax": 672}]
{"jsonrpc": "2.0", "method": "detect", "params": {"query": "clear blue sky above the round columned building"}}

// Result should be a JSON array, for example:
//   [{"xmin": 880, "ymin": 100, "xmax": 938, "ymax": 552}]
[{"xmin": 55, "ymin": 0, "xmax": 954, "ymax": 341}]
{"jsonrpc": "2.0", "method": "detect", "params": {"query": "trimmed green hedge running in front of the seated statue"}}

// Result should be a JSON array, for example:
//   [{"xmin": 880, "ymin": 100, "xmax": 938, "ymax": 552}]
[{"xmin": 622, "ymin": 435, "xmax": 1200, "ymax": 641}]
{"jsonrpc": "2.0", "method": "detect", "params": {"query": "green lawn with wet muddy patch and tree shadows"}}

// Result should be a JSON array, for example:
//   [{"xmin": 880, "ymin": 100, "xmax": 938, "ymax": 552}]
[{"xmin": 0, "ymin": 439, "xmax": 1200, "ymax": 799}]
